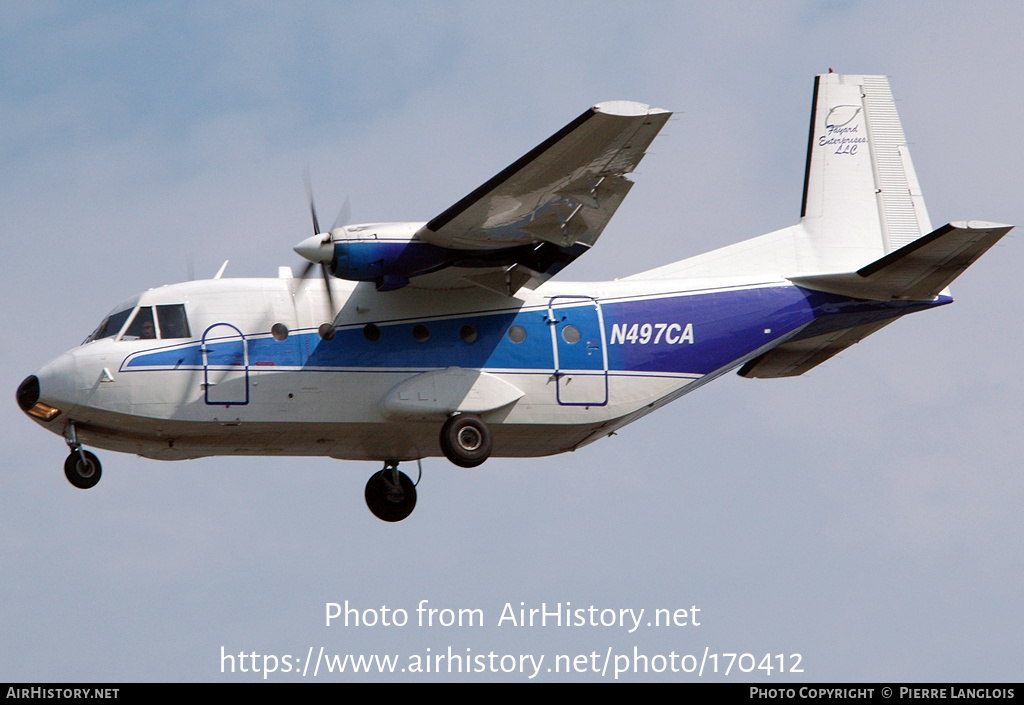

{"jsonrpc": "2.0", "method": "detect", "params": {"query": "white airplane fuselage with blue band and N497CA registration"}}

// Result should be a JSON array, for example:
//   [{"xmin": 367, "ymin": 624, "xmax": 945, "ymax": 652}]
[{"xmin": 19, "ymin": 272, "xmax": 948, "ymax": 461}]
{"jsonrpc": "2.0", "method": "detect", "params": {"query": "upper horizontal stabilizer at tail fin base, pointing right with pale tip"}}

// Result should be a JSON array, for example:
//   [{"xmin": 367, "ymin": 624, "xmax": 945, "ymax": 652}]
[{"xmin": 790, "ymin": 220, "xmax": 1013, "ymax": 301}]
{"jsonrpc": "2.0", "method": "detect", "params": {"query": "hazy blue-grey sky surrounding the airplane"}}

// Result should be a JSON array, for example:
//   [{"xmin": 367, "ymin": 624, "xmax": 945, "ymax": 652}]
[{"xmin": 0, "ymin": 1, "xmax": 1024, "ymax": 685}]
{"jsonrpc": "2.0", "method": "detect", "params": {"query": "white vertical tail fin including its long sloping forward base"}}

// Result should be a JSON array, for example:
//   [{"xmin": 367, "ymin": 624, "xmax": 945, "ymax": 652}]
[{"xmin": 634, "ymin": 74, "xmax": 932, "ymax": 279}]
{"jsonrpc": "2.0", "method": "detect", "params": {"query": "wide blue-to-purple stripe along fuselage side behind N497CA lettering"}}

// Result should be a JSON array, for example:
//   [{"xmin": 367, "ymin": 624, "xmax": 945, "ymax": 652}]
[{"xmin": 122, "ymin": 286, "xmax": 945, "ymax": 375}]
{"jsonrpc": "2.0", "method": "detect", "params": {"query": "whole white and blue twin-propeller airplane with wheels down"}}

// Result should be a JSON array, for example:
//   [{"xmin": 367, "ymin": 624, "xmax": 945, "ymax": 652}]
[{"xmin": 16, "ymin": 71, "xmax": 1012, "ymax": 522}]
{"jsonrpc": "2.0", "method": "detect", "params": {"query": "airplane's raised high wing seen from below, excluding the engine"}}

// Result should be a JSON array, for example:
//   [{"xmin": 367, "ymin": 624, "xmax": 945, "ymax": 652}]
[{"xmin": 413, "ymin": 100, "xmax": 672, "ymax": 295}]
